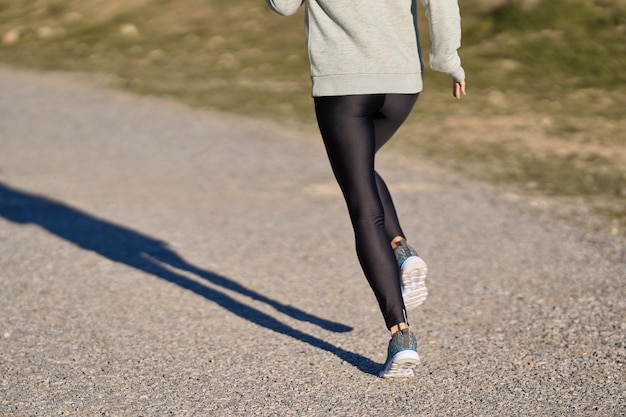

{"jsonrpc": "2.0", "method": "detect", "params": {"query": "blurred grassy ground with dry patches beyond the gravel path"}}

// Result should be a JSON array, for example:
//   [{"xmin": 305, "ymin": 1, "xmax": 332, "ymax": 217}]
[{"xmin": 0, "ymin": 0, "xmax": 626, "ymax": 234}]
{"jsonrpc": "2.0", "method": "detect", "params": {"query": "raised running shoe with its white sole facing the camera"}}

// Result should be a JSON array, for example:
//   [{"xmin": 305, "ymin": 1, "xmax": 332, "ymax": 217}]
[{"xmin": 393, "ymin": 239, "xmax": 428, "ymax": 310}]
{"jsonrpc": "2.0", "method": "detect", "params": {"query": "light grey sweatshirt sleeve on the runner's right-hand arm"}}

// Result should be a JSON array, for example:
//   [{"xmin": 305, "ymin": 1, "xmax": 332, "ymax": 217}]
[{"xmin": 420, "ymin": 0, "xmax": 465, "ymax": 81}]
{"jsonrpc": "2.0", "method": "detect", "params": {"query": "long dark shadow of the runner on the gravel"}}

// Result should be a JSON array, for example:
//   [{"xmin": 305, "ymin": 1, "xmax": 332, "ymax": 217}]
[{"xmin": 0, "ymin": 182, "xmax": 379, "ymax": 374}]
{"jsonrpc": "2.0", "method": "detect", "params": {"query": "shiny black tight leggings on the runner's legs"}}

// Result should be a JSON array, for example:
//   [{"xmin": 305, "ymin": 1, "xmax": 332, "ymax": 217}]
[{"xmin": 314, "ymin": 94, "xmax": 418, "ymax": 328}]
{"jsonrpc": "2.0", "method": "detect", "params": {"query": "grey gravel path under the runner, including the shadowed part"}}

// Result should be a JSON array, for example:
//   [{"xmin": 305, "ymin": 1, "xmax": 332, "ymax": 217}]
[{"xmin": 0, "ymin": 69, "xmax": 626, "ymax": 417}]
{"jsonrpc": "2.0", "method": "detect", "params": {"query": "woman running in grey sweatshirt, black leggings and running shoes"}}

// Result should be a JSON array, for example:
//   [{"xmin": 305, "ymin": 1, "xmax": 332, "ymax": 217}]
[{"xmin": 266, "ymin": 0, "xmax": 465, "ymax": 377}]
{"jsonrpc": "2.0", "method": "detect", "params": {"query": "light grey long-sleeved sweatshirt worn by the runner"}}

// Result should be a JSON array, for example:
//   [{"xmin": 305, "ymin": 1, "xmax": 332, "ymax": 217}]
[{"xmin": 266, "ymin": 0, "xmax": 465, "ymax": 97}]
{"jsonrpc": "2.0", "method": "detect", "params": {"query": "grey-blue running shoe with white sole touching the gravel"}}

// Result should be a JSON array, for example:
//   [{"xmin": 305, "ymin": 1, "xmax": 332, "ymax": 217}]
[{"xmin": 378, "ymin": 329, "xmax": 420, "ymax": 378}]
